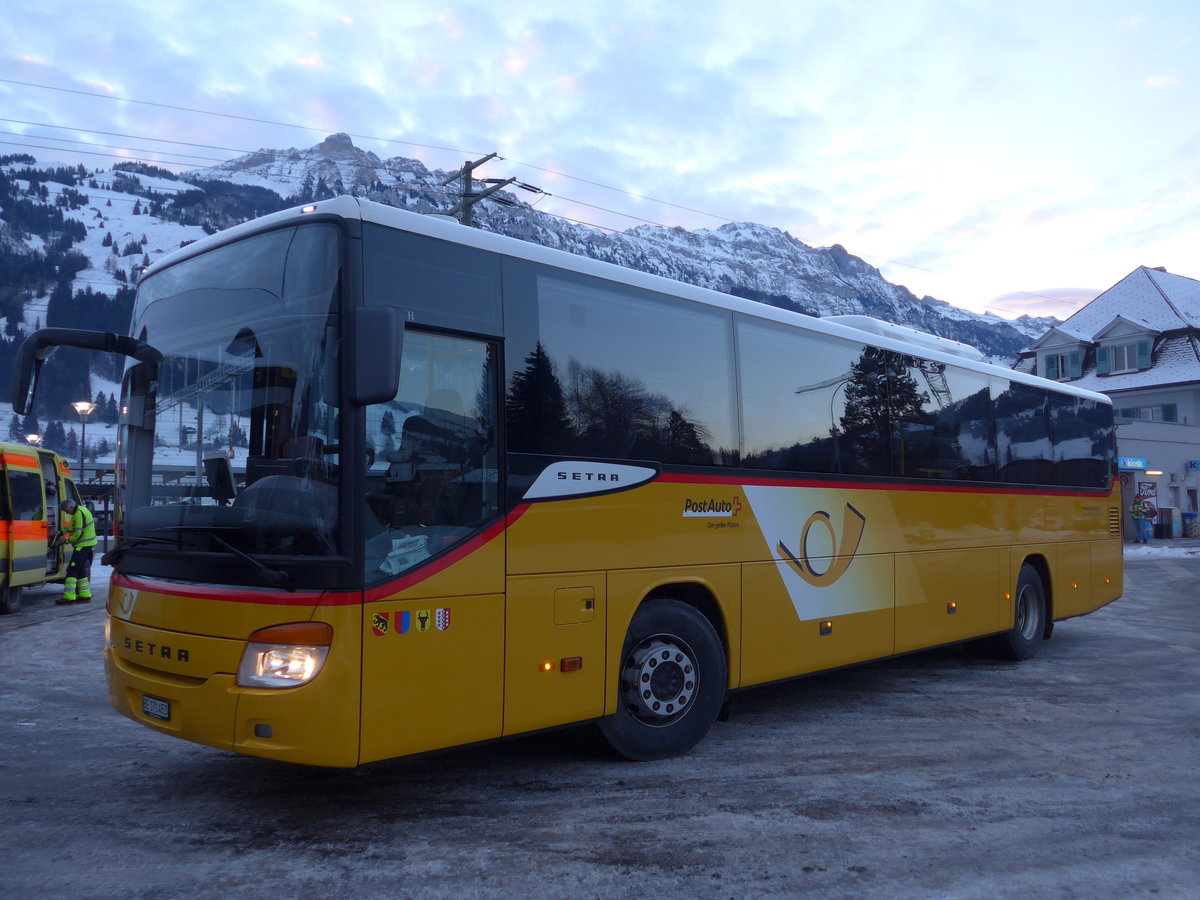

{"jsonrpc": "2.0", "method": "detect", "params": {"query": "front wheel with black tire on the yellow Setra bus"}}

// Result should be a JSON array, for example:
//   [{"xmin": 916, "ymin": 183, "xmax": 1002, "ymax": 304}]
[{"xmin": 600, "ymin": 599, "xmax": 728, "ymax": 761}]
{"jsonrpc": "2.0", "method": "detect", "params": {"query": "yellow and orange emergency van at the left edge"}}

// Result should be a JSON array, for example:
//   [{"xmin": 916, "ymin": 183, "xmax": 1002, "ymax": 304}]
[{"xmin": 0, "ymin": 443, "xmax": 80, "ymax": 614}]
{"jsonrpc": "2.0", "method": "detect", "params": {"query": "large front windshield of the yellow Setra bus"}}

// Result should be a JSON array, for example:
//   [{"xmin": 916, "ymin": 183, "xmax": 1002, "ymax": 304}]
[{"xmin": 118, "ymin": 223, "xmax": 343, "ymax": 586}]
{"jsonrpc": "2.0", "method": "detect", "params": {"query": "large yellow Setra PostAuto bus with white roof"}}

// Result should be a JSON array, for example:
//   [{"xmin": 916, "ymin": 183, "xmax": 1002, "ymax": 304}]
[{"xmin": 14, "ymin": 197, "xmax": 1122, "ymax": 767}]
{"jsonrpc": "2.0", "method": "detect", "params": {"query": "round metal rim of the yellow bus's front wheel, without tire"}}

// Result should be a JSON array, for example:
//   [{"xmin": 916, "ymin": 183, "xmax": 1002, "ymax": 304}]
[{"xmin": 622, "ymin": 635, "xmax": 700, "ymax": 727}]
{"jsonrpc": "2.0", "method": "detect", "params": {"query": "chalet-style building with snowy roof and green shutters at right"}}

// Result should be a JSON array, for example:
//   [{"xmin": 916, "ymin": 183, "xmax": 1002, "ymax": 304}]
[{"xmin": 1013, "ymin": 266, "xmax": 1200, "ymax": 536}]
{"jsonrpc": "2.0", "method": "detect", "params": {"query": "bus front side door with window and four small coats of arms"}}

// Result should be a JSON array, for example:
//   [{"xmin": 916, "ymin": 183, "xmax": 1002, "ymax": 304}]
[{"xmin": 360, "ymin": 330, "xmax": 505, "ymax": 762}]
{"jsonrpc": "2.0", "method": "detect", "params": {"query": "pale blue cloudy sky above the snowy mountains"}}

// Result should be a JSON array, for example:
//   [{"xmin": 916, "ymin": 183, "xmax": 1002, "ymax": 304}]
[{"xmin": 0, "ymin": 0, "xmax": 1200, "ymax": 317}]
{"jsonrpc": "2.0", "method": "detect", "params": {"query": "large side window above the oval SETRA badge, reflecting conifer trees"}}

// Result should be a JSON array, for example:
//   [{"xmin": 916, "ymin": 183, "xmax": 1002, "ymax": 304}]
[{"xmin": 506, "ymin": 271, "xmax": 737, "ymax": 464}]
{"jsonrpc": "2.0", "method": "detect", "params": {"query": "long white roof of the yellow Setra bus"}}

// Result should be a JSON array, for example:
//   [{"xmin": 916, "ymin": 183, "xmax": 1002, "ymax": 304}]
[{"xmin": 143, "ymin": 196, "xmax": 1111, "ymax": 403}]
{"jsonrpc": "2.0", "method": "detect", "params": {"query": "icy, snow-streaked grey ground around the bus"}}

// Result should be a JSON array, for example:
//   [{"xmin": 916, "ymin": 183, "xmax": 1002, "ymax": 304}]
[{"xmin": 0, "ymin": 551, "xmax": 1200, "ymax": 900}]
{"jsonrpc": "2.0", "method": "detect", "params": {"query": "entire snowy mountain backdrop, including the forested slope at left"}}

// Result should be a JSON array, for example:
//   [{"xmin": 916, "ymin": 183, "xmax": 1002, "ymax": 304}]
[{"xmin": 0, "ymin": 134, "xmax": 1056, "ymax": 451}]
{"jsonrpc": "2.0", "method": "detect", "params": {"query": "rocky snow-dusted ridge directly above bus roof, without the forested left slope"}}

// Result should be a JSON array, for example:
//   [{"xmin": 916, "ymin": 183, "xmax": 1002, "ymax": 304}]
[{"xmin": 187, "ymin": 134, "xmax": 1056, "ymax": 362}]
